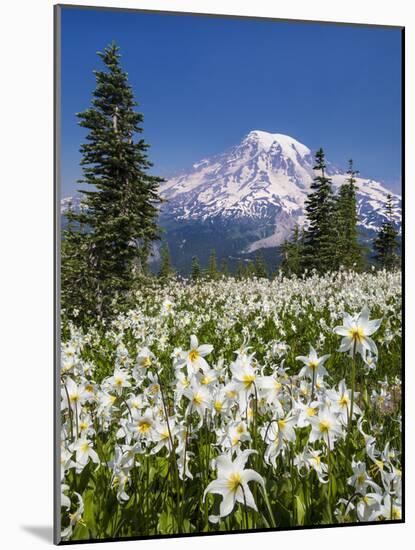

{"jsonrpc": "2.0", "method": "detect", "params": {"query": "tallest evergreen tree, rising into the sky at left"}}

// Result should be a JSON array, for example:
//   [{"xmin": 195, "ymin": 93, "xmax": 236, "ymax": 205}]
[{"xmin": 62, "ymin": 43, "xmax": 163, "ymax": 316}]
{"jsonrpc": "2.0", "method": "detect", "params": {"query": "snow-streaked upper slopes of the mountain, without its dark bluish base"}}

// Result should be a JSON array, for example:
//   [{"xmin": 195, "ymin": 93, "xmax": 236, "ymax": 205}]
[{"xmin": 161, "ymin": 130, "xmax": 400, "ymax": 252}]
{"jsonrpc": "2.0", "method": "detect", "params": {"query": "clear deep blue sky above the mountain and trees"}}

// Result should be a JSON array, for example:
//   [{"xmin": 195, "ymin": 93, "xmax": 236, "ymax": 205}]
[{"xmin": 61, "ymin": 8, "xmax": 402, "ymax": 196}]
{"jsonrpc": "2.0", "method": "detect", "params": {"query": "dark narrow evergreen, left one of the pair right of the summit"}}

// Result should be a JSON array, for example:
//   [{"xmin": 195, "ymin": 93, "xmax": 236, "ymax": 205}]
[{"xmin": 304, "ymin": 148, "xmax": 336, "ymax": 273}]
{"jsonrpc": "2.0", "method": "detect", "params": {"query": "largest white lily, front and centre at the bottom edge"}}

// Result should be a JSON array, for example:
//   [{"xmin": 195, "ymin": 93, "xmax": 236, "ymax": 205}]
[{"xmin": 203, "ymin": 449, "xmax": 265, "ymax": 521}]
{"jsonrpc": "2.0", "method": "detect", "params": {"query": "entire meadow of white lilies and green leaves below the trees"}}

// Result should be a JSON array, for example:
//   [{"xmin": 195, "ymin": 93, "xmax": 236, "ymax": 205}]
[{"xmin": 60, "ymin": 270, "xmax": 402, "ymax": 541}]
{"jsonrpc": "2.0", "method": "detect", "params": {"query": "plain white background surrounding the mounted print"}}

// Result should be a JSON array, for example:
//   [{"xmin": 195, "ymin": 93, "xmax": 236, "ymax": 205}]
[{"xmin": 0, "ymin": 0, "xmax": 415, "ymax": 550}]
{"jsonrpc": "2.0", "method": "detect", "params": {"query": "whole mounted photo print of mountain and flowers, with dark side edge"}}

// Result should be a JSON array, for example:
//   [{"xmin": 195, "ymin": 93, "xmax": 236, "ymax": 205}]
[{"xmin": 55, "ymin": 5, "xmax": 404, "ymax": 544}]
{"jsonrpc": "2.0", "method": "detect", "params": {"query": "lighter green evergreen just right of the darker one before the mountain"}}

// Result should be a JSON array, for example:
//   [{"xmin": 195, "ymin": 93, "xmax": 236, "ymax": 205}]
[{"xmin": 334, "ymin": 160, "xmax": 364, "ymax": 271}]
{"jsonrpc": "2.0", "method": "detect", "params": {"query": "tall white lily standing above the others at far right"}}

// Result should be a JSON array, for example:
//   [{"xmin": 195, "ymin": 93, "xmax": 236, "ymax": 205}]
[{"xmin": 333, "ymin": 306, "xmax": 382, "ymax": 358}]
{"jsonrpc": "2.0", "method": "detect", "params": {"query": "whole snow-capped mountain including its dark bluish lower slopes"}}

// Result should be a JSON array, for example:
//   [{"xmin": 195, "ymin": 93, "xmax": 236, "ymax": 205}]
[{"xmin": 61, "ymin": 130, "xmax": 401, "ymax": 273}]
